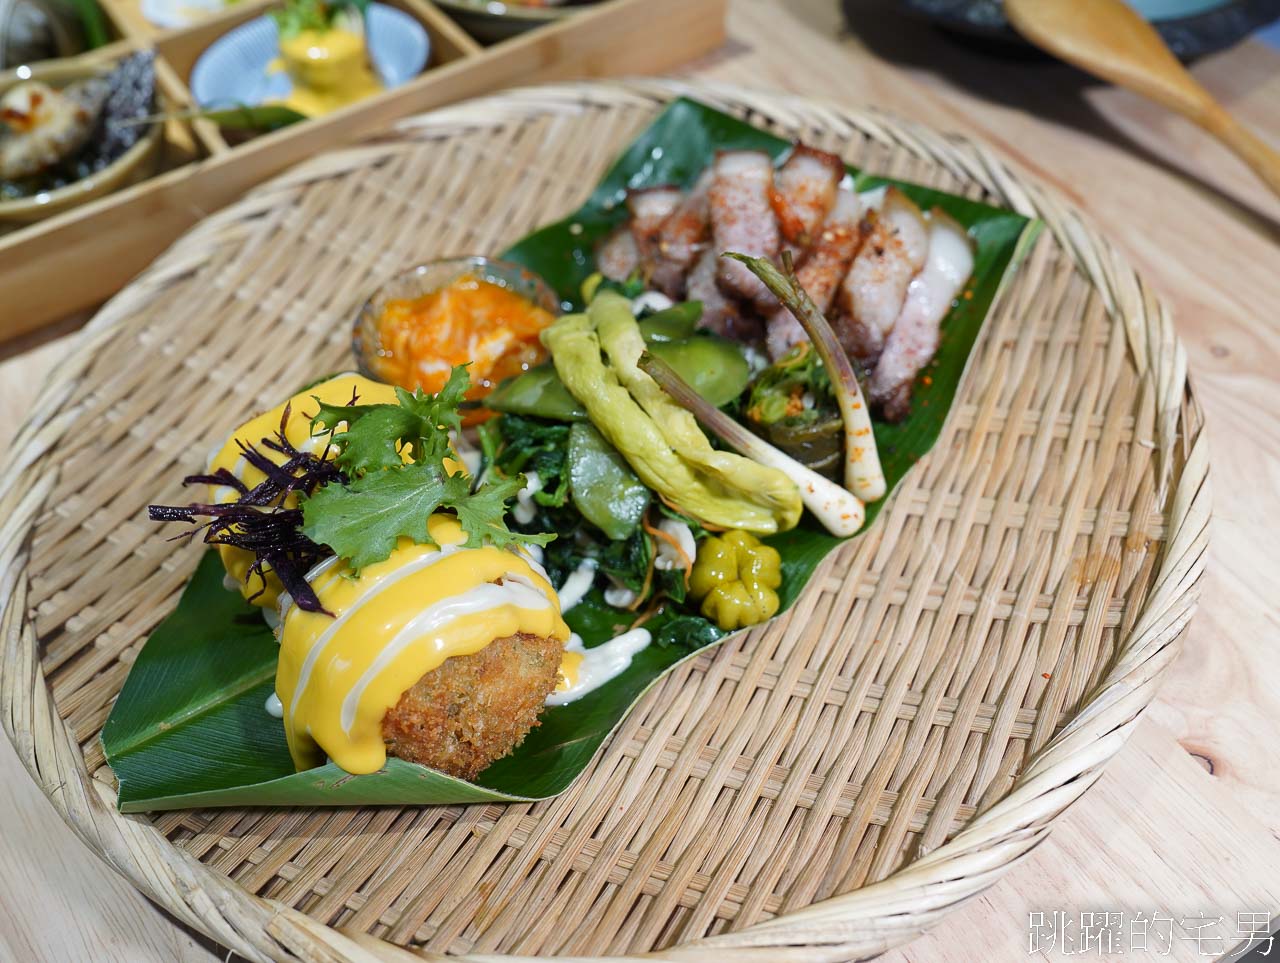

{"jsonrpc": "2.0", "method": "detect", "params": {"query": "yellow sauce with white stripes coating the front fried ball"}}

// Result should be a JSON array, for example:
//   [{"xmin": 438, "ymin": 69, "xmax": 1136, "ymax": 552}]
[{"xmin": 275, "ymin": 515, "xmax": 570, "ymax": 775}]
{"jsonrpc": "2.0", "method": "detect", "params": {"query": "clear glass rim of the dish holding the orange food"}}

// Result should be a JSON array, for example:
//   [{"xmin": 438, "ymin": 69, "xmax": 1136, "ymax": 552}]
[{"xmin": 351, "ymin": 255, "xmax": 561, "ymax": 380}]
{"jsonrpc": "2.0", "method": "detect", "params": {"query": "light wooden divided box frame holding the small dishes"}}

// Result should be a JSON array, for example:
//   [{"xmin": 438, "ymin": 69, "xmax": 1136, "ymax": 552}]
[{"xmin": 0, "ymin": 0, "xmax": 726, "ymax": 341}]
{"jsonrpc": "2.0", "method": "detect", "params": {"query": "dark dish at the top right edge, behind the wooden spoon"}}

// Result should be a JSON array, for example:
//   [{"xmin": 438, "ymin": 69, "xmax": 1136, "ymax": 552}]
[{"xmin": 896, "ymin": 0, "xmax": 1280, "ymax": 60}]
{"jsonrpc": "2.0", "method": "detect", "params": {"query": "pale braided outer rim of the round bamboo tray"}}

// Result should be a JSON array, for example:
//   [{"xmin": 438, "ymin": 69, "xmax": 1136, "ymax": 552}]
[{"xmin": 0, "ymin": 79, "xmax": 1211, "ymax": 963}]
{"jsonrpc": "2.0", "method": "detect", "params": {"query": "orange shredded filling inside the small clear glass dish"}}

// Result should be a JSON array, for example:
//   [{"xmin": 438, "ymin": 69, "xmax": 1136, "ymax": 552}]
[{"xmin": 369, "ymin": 274, "xmax": 556, "ymax": 412}]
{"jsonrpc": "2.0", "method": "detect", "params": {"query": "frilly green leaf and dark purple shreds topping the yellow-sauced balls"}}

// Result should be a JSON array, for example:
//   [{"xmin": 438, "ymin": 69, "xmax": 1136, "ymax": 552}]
[{"xmin": 148, "ymin": 365, "xmax": 554, "ymax": 612}]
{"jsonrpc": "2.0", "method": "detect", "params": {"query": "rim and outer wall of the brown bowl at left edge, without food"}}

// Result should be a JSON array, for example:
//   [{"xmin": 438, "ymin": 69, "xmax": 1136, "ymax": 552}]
[{"xmin": 0, "ymin": 59, "xmax": 164, "ymax": 224}]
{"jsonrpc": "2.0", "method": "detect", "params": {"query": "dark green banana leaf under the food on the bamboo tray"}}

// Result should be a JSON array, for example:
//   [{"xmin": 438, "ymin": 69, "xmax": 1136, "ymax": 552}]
[{"xmin": 102, "ymin": 100, "xmax": 1039, "ymax": 812}]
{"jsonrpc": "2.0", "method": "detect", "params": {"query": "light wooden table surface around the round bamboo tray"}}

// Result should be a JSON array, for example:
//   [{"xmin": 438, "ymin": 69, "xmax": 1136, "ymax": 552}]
[{"xmin": 0, "ymin": 0, "xmax": 1280, "ymax": 963}]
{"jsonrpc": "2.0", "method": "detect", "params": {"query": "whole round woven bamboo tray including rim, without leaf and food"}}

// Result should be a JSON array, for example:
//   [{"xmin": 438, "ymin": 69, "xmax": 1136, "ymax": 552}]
[{"xmin": 0, "ymin": 82, "xmax": 1210, "ymax": 960}]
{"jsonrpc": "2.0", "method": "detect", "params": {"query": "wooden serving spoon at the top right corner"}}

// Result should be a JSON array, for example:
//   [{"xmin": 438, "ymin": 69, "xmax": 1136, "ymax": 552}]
[{"xmin": 1005, "ymin": 0, "xmax": 1280, "ymax": 196}]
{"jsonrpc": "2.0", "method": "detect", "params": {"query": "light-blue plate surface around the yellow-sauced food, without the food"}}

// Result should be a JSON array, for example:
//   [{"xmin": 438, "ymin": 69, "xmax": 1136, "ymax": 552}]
[{"xmin": 191, "ymin": 4, "xmax": 431, "ymax": 109}]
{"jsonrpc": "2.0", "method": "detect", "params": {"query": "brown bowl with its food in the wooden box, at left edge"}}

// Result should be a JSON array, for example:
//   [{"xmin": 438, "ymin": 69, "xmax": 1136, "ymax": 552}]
[{"xmin": 0, "ymin": 53, "xmax": 163, "ymax": 222}]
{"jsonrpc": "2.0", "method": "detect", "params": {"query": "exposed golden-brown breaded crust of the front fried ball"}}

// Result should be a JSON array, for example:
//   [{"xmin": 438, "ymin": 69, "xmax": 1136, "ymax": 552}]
[{"xmin": 383, "ymin": 634, "xmax": 564, "ymax": 779}]
